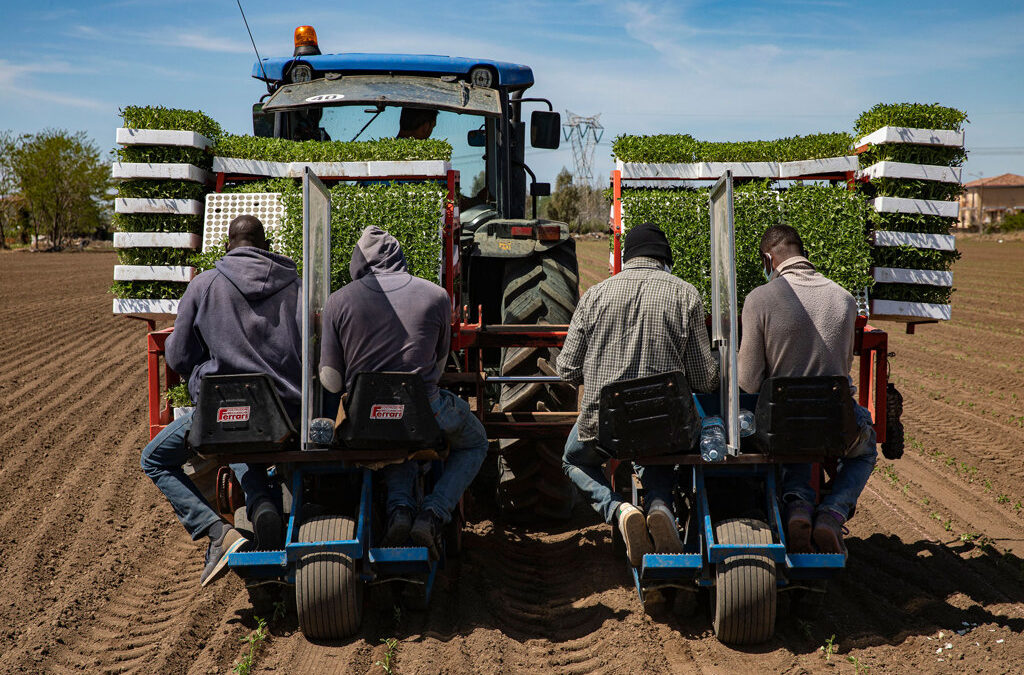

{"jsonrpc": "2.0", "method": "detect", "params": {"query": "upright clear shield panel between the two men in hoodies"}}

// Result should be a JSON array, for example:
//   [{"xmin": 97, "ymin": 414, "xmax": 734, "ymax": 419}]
[{"xmin": 301, "ymin": 167, "xmax": 331, "ymax": 450}]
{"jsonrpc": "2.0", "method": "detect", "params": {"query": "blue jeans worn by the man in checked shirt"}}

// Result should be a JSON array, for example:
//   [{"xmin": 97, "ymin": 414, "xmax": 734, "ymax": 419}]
[{"xmin": 562, "ymin": 422, "xmax": 676, "ymax": 523}]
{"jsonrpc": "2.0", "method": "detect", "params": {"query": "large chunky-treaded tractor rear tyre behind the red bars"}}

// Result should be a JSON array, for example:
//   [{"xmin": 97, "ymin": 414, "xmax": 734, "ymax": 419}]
[{"xmin": 498, "ymin": 240, "xmax": 580, "ymax": 520}]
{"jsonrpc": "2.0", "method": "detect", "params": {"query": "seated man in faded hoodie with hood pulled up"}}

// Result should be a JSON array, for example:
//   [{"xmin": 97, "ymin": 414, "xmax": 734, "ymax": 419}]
[{"xmin": 319, "ymin": 225, "xmax": 487, "ymax": 559}]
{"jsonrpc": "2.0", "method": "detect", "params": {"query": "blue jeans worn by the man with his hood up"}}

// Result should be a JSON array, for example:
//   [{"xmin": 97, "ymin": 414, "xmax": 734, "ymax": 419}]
[{"xmin": 381, "ymin": 389, "xmax": 487, "ymax": 522}]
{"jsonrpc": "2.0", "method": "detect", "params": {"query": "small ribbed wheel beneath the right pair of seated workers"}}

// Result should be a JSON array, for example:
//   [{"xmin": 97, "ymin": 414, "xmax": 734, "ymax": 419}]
[{"xmin": 712, "ymin": 518, "xmax": 776, "ymax": 644}]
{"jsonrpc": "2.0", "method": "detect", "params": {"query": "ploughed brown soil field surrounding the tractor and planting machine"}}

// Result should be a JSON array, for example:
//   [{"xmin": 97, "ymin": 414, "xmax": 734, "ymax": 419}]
[{"xmin": 0, "ymin": 238, "xmax": 1024, "ymax": 673}]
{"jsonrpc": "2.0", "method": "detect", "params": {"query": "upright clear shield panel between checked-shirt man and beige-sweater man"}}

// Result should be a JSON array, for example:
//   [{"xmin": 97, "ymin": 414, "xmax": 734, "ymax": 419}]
[{"xmin": 709, "ymin": 171, "xmax": 739, "ymax": 456}]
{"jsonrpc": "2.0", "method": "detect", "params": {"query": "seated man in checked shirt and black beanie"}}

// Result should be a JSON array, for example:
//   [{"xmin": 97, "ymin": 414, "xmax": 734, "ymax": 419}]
[{"xmin": 556, "ymin": 222, "xmax": 718, "ymax": 566}]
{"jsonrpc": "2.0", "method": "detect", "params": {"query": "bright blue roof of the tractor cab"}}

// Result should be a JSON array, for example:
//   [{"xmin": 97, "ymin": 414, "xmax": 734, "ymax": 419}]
[{"xmin": 253, "ymin": 53, "xmax": 534, "ymax": 89}]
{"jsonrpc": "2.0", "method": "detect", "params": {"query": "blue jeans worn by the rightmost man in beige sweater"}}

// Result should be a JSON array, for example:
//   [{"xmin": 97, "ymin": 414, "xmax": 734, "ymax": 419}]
[{"xmin": 782, "ymin": 405, "xmax": 879, "ymax": 519}]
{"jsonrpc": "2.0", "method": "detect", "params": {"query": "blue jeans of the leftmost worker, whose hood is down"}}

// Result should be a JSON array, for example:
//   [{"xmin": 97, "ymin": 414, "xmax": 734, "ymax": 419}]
[{"xmin": 141, "ymin": 412, "xmax": 272, "ymax": 540}]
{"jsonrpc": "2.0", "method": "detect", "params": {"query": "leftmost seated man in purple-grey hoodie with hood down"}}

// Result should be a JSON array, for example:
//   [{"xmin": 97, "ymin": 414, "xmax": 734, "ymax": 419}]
[{"xmin": 141, "ymin": 215, "xmax": 302, "ymax": 586}]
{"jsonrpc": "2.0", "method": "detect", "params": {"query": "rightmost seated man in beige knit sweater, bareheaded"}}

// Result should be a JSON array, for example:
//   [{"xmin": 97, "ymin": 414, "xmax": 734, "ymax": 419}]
[{"xmin": 738, "ymin": 225, "xmax": 877, "ymax": 554}]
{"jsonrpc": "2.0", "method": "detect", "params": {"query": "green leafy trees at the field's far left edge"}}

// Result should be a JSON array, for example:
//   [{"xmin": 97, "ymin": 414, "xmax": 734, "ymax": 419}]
[{"xmin": 0, "ymin": 129, "xmax": 113, "ymax": 250}]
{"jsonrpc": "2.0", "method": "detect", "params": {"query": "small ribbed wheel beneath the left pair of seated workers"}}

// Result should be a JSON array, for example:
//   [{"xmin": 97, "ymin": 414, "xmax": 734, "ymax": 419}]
[{"xmin": 295, "ymin": 515, "xmax": 362, "ymax": 639}]
